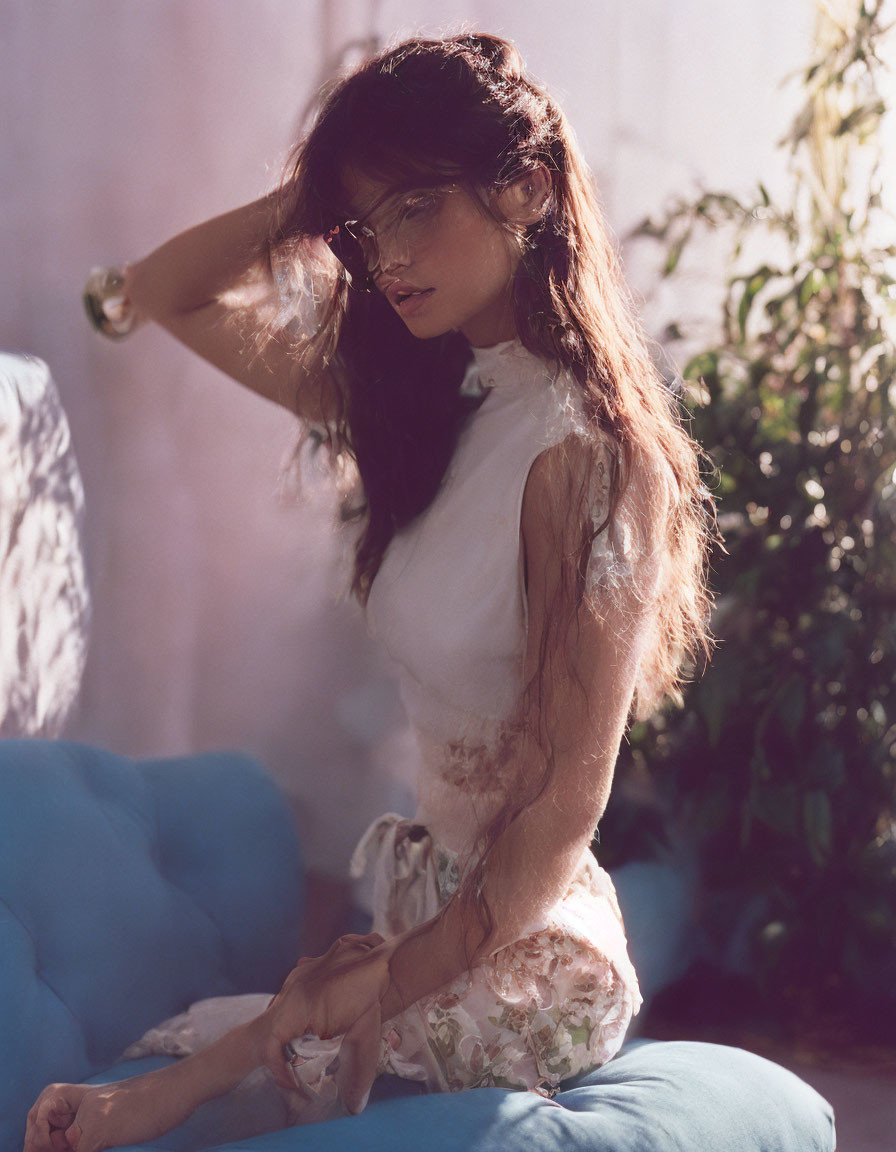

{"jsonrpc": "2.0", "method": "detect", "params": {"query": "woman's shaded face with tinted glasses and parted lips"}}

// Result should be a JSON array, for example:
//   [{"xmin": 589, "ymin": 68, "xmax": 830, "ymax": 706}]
[{"xmin": 336, "ymin": 170, "xmax": 521, "ymax": 347}]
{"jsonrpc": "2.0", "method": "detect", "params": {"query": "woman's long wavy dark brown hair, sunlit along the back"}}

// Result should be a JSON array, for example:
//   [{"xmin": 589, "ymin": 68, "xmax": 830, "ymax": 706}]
[{"xmin": 272, "ymin": 33, "xmax": 715, "ymax": 958}]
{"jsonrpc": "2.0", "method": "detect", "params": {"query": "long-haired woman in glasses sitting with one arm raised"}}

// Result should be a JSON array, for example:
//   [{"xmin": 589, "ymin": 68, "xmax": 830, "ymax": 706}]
[{"xmin": 25, "ymin": 35, "xmax": 712, "ymax": 1152}]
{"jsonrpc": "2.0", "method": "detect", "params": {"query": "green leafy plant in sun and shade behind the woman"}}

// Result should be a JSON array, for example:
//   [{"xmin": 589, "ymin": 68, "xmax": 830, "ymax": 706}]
[{"xmin": 609, "ymin": 0, "xmax": 896, "ymax": 1037}]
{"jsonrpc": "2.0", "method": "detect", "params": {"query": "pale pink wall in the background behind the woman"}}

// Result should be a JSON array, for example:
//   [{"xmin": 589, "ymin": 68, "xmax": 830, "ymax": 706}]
[{"xmin": 0, "ymin": 0, "xmax": 812, "ymax": 871}]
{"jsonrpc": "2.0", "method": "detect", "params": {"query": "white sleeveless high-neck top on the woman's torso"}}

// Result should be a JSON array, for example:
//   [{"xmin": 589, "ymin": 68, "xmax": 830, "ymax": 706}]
[{"xmin": 367, "ymin": 340, "xmax": 609, "ymax": 850}]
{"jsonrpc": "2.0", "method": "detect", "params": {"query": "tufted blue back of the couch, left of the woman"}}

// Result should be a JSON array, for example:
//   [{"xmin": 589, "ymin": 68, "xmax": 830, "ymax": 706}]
[{"xmin": 0, "ymin": 740, "xmax": 302, "ymax": 1149}]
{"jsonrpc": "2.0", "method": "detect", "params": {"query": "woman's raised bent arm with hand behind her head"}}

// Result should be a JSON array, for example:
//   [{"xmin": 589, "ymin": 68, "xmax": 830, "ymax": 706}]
[{"xmin": 124, "ymin": 192, "xmax": 334, "ymax": 423}]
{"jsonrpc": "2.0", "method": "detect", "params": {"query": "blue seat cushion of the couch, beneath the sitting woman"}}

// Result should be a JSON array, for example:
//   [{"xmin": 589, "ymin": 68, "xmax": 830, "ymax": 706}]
[{"xmin": 81, "ymin": 1040, "xmax": 835, "ymax": 1152}]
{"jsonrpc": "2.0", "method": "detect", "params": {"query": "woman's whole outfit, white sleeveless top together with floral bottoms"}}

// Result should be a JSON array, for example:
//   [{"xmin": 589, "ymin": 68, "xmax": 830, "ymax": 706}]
[{"xmin": 127, "ymin": 341, "xmax": 641, "ymax": 1119}]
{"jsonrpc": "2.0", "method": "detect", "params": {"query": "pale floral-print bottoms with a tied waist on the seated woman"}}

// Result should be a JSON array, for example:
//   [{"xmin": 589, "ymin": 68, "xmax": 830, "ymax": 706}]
[{"xmin": 124, "ymin": 813, "xmax": 641, "ymax": 1121}]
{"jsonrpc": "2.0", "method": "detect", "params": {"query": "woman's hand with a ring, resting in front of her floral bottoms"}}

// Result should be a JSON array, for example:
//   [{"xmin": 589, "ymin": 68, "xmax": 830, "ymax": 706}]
[{"xmin": 257, "ymin": 933, "xmax": 394, "ymax": 1113}]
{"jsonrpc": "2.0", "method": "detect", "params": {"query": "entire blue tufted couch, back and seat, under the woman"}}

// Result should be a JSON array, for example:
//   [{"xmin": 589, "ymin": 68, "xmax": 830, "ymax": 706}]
[{"xmin": 0, "ymin": 740, "xmax": 835, "ymax": 1152}]
